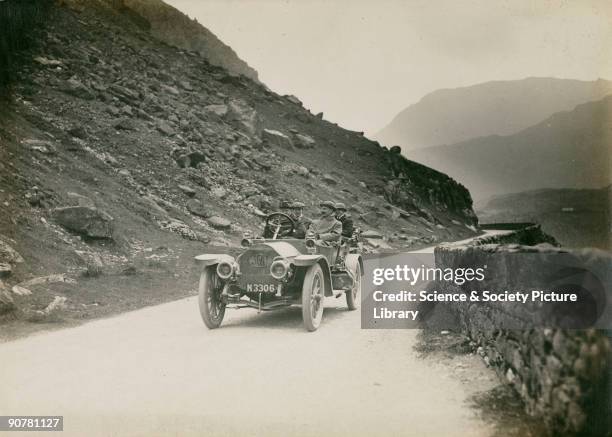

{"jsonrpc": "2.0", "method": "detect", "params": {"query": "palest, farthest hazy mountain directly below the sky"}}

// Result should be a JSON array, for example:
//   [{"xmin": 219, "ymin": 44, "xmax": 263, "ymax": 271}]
[{"xmin": 375, "ymin": 78, "xmax": 612, "ymax": 148}]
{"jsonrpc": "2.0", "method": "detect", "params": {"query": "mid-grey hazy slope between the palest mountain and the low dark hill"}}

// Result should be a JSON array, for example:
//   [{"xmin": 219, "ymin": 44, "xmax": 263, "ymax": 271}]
[{"xmin": 406, "ymin": 96, "xmax": 612, "ymax": 200}]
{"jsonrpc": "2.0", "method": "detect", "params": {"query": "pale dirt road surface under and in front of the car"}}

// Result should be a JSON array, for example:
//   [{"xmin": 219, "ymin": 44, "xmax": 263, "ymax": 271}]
[{"xmin": 0, "ymin": 230, "xmax": 512, "ymax": 436}]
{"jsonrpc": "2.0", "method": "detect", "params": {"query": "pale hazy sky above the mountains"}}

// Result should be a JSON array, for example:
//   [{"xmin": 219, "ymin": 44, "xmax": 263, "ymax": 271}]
[{"xmin": 166, "ymin": 0, "xmax": 612, "ymax": 134}]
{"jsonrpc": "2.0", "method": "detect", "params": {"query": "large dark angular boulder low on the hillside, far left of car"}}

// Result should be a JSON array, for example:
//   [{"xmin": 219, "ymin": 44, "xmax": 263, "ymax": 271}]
[{"xmin": 52, "ymin": 206, "xmax": 113, "ymax": 238}]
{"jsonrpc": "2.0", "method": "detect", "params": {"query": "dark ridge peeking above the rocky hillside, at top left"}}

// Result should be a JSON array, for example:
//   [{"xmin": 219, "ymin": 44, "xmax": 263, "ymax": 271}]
[{"xmin": 120, "ymin": 0, "xmax": 258, "ymax": 81}]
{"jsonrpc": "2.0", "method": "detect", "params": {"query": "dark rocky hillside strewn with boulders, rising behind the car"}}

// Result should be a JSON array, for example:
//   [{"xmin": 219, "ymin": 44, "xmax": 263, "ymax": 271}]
[{"xmin": 0, "ymin": 0, "xmax": 475, "ymax": 328}]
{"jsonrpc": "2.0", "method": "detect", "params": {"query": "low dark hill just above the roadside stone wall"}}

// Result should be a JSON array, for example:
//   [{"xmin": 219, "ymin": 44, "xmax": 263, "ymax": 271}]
[{"xmin": 476, "ymin": 186, "xmax": 612, "ymax": 250}]
